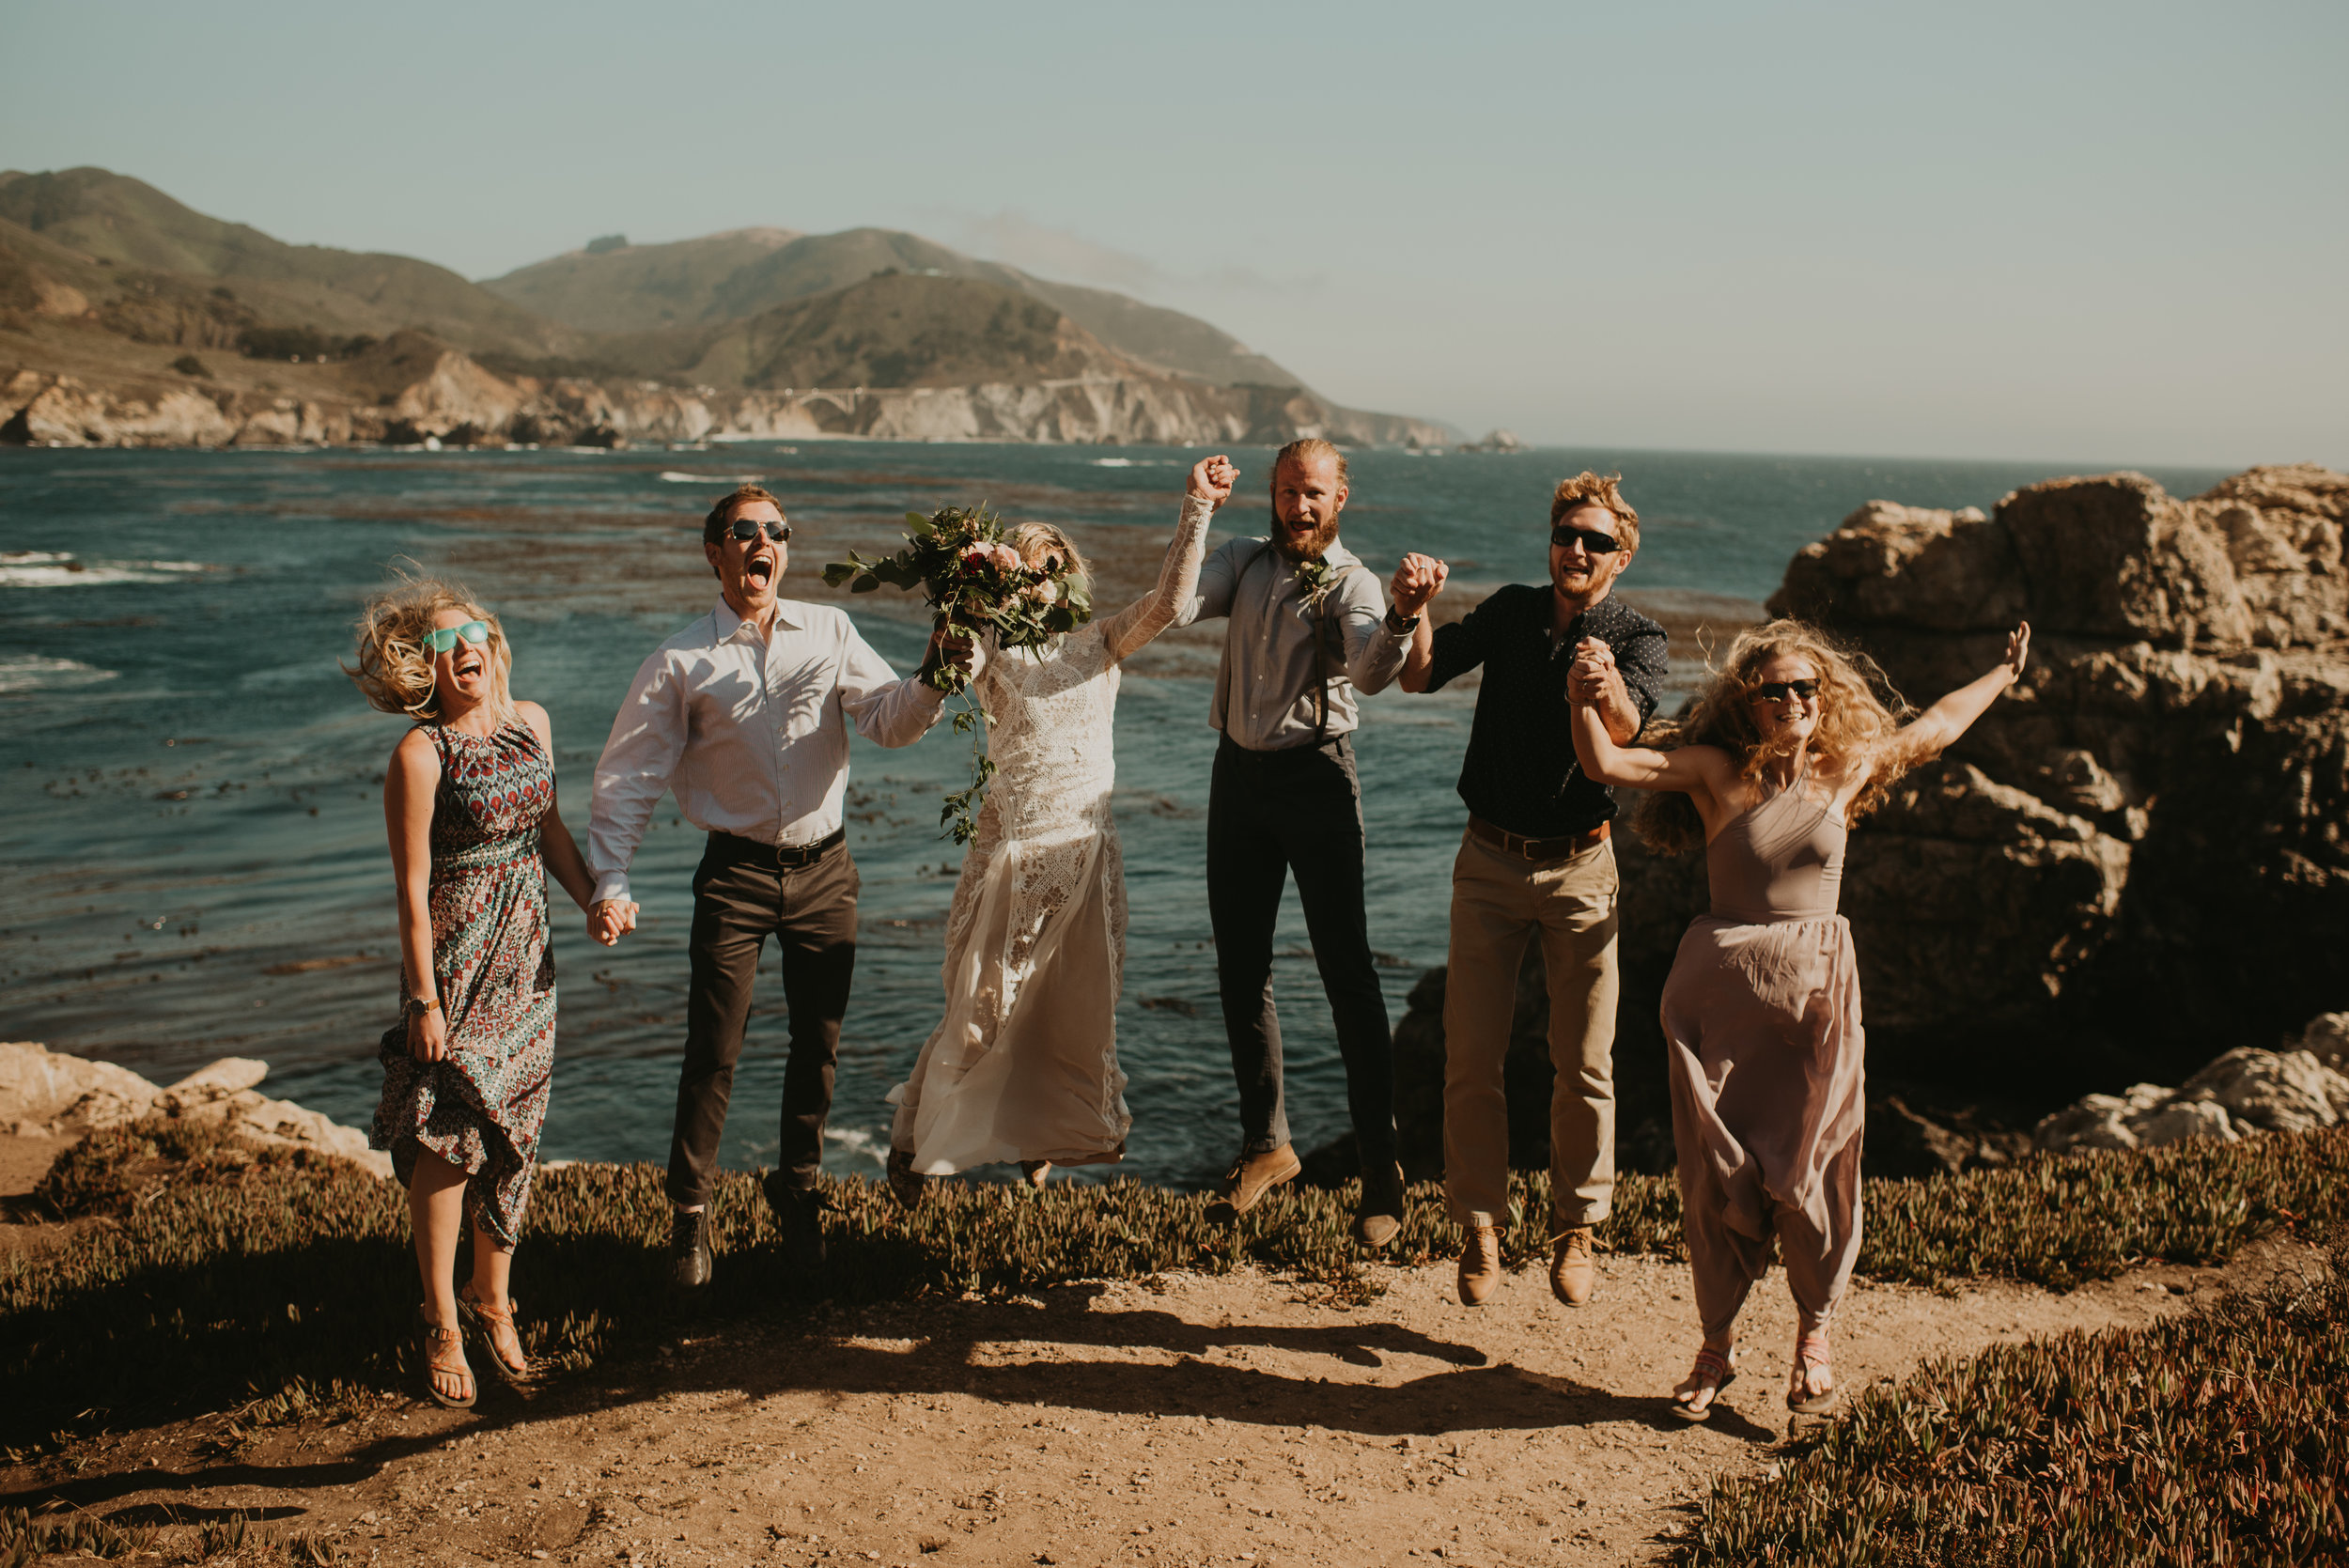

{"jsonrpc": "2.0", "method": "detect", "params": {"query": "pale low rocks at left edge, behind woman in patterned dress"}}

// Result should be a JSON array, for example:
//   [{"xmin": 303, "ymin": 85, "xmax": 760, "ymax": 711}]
[{"xmin": 0, "ymin": 1042, "xmax": 393, "ymax": 1176}]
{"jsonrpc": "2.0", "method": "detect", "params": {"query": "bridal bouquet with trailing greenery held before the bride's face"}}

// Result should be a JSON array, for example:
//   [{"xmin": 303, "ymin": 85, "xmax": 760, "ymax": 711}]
[{"xmin": 825, "ymin": 503, "xmax": 1093, "ymax": 845}]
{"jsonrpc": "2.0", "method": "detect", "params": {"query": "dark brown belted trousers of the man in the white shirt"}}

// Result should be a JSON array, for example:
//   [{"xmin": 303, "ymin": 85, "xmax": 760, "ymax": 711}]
[{"xmin": 670, "ymin": 833, "xmax": 858, "ymax": 1206}]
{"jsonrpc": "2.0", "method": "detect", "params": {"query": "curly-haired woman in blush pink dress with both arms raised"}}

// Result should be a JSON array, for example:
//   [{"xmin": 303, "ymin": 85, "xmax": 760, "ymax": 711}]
[{"xmin": 1574, "ymin": 620, "xmax": 2032, "ymax": 1421}]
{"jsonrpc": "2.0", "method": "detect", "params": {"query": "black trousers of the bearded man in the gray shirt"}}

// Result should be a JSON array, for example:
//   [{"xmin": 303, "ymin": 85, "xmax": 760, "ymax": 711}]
[{"xmin": 1207, "ymin": 735, "xmax": 1395, "ymax": 1169}]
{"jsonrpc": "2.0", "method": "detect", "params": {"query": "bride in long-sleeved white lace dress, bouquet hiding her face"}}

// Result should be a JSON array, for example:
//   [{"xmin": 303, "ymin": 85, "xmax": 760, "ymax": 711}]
[{"xmin": 888, "ymin": 458, "xmax": 1238, "ymax": 1202}]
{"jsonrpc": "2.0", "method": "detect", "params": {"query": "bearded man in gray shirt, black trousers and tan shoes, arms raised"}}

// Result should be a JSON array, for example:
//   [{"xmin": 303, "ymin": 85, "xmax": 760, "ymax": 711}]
[{"xmin": 1174, "ymin": 439, "xmax": 1440, "ymax": 1247}]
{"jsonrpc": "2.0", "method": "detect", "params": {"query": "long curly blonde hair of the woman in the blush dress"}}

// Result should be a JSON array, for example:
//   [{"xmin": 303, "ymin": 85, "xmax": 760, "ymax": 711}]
[{"xmin": 1633, "ymin": 620, "xmax": 1910, "ymax": 854}]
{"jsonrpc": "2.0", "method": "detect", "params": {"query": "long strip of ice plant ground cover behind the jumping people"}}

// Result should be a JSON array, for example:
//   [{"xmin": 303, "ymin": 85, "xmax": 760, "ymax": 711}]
[{"xmin": 0, "ymin": 1120, "xmax": 2349, "ymax": 1451}]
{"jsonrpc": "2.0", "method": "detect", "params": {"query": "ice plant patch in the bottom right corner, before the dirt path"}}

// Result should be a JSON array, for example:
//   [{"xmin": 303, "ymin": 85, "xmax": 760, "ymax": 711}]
[{"xmin": 1680, "ymin": 1233, "xmax": 2349, "ymax": 1568}]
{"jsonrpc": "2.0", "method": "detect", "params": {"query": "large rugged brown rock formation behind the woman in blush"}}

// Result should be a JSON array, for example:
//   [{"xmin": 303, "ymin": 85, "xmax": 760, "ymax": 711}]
[{"xmin": 1619, "ymin": 465, "xmax": 2349, "ymax": 1108}]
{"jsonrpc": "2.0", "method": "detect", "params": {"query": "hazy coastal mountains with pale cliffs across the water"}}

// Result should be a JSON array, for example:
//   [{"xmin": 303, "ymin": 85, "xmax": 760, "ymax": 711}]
[{"xmin": 0, "ymin": 169, "xmax": 1452, "ymax": 446}]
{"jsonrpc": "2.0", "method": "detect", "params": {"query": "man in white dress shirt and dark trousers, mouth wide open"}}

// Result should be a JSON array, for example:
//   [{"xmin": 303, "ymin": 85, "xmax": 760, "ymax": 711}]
[{"xmin": 587, "ymin": 486, "xmax": 968, "ymax": 1289}]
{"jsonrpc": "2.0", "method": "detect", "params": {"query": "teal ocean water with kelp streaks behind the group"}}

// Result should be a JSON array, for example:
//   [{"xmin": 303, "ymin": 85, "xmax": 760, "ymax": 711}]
[{"xmin": 0, "ymin": 443, "xmax": 2220, "ymax": 1183}]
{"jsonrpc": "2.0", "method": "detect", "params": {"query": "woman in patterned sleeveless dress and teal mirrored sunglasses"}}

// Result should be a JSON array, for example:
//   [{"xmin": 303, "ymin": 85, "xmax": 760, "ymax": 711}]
[{"xmin": 346, "ymin": 582, "xmax": 595, "ymax": 1408}]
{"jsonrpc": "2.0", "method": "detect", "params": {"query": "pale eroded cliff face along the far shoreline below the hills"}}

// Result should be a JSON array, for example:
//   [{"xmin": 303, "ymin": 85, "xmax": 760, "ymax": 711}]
[{"xmin": 0, "ymin": 334, "xmax": 1450, "ymax": 448}]
